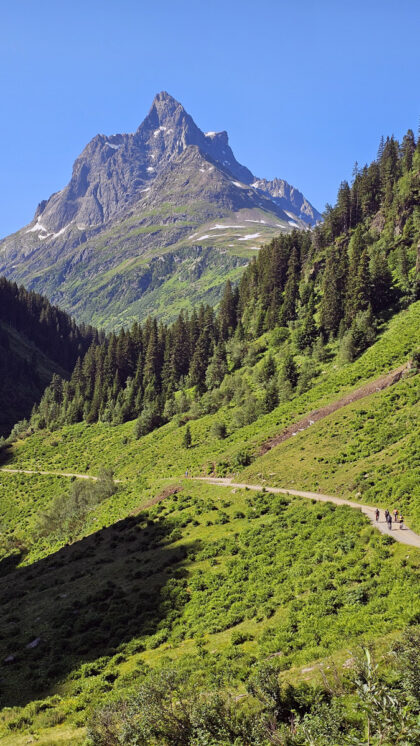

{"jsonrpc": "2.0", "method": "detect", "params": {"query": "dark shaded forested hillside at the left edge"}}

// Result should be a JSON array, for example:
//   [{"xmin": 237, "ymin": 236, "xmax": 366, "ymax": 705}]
[{"xmin": 0, "ymin": 277, "xmax": 101, "ymax": 435}]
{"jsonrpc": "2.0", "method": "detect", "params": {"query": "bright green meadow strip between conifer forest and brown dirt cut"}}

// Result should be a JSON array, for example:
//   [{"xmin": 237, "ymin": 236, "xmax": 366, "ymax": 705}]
[{"xmin": 5, "ymin": 303, "xmax": 420, "ymax": 499}]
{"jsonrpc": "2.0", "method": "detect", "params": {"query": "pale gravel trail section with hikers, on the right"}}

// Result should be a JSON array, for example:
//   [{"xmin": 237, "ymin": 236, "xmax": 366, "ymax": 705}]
[{"xmin": 191, "ymin": 477, "xmax": 420, "ymax": 549}]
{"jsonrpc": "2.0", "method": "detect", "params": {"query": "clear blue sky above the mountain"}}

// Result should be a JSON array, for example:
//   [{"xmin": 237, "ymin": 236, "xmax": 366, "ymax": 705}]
[{"xmin": 0, "ymin": 0, "xmax": 420, "ymax": 236}]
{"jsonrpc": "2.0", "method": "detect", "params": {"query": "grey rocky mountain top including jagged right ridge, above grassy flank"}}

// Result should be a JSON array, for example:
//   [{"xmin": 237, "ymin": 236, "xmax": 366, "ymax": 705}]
[{"xmin": 2, "ymin": 91, "xmax": 319, "ymax": 241}]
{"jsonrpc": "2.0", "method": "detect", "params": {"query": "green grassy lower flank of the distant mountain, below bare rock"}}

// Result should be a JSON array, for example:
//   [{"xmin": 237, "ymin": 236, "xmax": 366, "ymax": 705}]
[{"xmin": 13, "ymin": 201, "xmax": 291, "ymax": 329}]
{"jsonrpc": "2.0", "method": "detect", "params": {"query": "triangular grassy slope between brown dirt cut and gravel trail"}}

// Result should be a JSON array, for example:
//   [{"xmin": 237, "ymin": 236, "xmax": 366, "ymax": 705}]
[{"xmin": 241, "ymin": 375, "xmax": 420, "ymax": 532}]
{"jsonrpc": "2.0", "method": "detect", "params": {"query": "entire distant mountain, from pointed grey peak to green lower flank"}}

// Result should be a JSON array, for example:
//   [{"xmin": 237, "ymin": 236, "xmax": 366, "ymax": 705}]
[{"xmin": 0, "ymin": 92, "xmax": 321, "ymax": 326}]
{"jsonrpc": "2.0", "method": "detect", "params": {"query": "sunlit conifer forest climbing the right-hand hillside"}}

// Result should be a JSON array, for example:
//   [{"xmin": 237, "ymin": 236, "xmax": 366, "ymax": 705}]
[{"xmin": 33, "ymin": 130, "xmax": 420, "ymax": 435}]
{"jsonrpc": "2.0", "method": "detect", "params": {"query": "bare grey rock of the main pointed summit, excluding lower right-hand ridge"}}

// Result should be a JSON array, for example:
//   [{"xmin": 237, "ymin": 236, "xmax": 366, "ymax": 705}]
[{"xmin": 36, "ymin": 92, "xmax": 260, "ymax": 233}]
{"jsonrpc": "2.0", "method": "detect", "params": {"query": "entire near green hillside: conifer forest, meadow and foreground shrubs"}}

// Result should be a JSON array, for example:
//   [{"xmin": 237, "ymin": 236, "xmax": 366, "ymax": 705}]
[{"xmin": 0, "ymin": 128, "xmax": 420, "ymax": 746}]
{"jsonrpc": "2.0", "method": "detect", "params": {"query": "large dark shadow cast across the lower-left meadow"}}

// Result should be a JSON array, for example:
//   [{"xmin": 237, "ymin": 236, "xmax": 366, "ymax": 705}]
[{"xmin": 0, "ymin": 514, "xmax": 199, "ymax": 706}]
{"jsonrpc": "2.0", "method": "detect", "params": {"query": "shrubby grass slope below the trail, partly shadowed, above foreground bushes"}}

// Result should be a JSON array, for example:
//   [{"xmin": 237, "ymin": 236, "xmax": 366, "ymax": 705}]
[{"xmin": 0, "ymin": 483, "xmax": 420, "ymax": 734}]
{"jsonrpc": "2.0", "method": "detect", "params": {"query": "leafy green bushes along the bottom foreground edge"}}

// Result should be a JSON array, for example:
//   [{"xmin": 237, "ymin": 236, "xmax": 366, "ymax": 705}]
[{"xmin": 88, "ymin": 631, "xmax": 420, "ymax": 746}]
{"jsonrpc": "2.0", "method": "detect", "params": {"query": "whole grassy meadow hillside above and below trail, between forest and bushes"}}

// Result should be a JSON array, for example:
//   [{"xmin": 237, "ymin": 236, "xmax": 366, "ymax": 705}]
[{"xmin": 0, "ymin": 303, "xmax": 420, "ymax": 743}]
